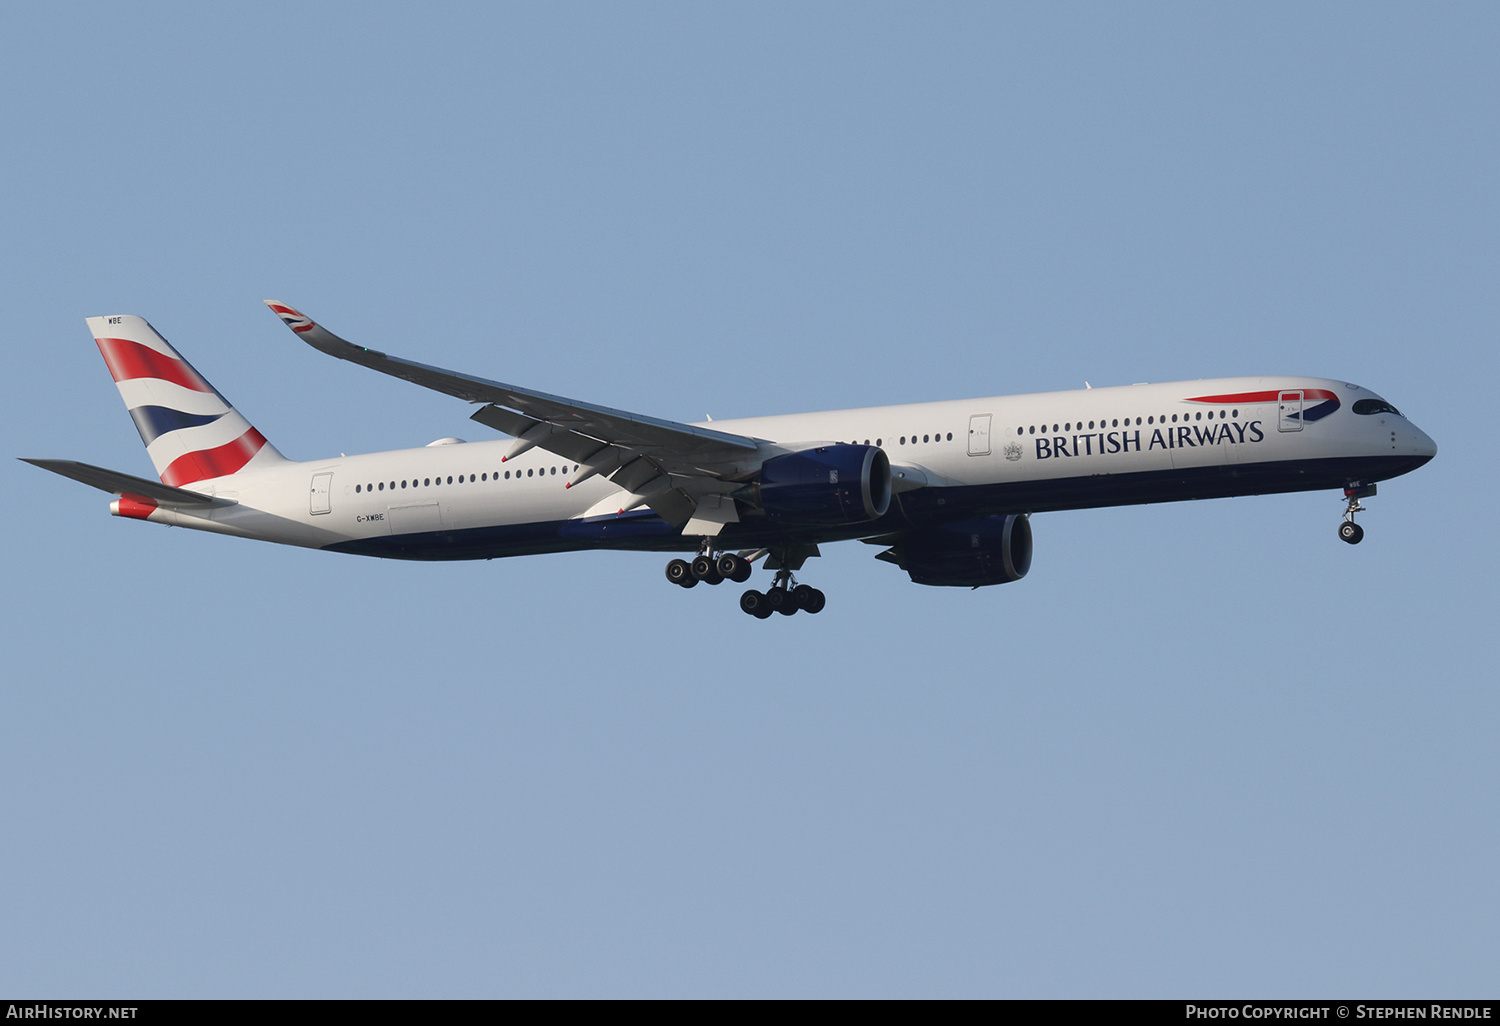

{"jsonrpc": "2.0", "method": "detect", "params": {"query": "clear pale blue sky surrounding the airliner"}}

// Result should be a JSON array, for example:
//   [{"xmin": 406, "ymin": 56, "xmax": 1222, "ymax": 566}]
[{"xmin": 0, "ymin": 3, "xmax": 1500, "ymax": 998}]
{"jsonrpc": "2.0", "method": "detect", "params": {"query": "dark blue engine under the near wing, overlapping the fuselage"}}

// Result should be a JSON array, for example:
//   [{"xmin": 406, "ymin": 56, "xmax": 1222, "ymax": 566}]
[{"xmin": 753, "ymin": 446, "xmax": 891, "ymax": 524}]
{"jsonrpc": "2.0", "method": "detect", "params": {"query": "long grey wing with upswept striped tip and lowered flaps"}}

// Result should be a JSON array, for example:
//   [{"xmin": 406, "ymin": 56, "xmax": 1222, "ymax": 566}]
[{"xmin": 266, "ymin": 300, "xmax": 785, "ymax": 533}]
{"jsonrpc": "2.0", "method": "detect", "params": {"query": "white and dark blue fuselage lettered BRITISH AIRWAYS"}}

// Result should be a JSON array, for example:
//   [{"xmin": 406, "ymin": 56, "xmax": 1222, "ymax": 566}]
[{"xmin": 129, "ymin": 377, "xmax": 1436, "ymax": 560}]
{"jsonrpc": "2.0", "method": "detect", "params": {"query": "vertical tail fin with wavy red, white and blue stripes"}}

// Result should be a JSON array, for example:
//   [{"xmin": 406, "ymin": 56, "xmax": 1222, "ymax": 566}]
[{"xmin": 89, "ymin": 317, "xmax": 287, "ymax": 488}]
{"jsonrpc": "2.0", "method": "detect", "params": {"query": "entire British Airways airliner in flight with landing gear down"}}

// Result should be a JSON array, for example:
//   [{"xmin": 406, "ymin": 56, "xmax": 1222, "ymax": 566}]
[{"xmin": 26, "ymin": 300, "xmax": 1437, "ymax": 620}]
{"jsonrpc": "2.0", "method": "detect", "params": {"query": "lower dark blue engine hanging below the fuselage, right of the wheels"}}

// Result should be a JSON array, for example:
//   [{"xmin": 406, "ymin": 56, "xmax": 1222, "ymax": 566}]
[{"xmin": 876, "ymin": 515, "xmax": 1032, "ymax": 588}]
